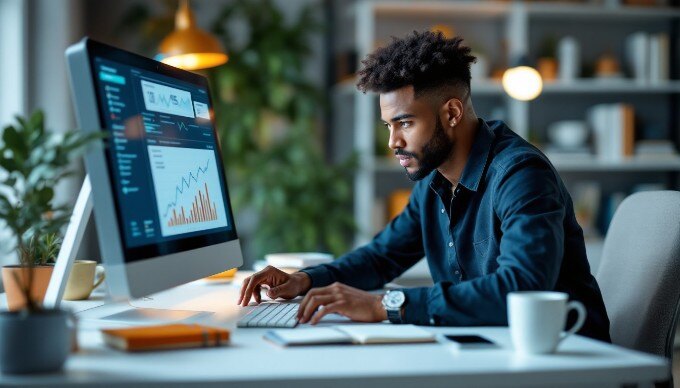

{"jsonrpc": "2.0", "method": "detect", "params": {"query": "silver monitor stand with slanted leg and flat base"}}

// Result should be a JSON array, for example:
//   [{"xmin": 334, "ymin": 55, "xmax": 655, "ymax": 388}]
[{"xmin": 43, "ymin": 175, "xmax": 213, "ymax": 324}]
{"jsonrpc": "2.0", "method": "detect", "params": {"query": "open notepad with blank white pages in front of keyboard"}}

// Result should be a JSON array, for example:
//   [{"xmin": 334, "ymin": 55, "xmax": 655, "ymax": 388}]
[{"xmin": 264, "ymin": 324, "xmax": 435, "ymax": 346}]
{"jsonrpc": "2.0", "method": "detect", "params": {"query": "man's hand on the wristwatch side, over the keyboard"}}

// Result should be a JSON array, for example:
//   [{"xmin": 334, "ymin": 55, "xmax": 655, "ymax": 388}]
[{"xmin": 298, "ymin": 283, "xmax": 387, "ymax": 325}]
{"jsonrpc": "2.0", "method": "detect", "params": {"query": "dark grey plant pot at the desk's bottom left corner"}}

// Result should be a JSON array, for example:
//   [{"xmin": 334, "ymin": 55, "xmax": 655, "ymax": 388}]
[{"xmin": 0, "ymin": 310, "xmax": 71, "ymax": 373}]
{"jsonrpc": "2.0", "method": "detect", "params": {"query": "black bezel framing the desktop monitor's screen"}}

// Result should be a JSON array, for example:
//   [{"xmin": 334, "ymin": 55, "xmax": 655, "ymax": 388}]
[{"xmin": 86, "ymin": 39, "xmax": 238, "ymax": 263}]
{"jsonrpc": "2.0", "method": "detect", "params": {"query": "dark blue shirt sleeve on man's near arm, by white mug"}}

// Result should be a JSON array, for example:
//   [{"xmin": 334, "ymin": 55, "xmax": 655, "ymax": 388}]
[{"xmin": 403, "ymin": 156, "xmax": 565, "ymax": 326}]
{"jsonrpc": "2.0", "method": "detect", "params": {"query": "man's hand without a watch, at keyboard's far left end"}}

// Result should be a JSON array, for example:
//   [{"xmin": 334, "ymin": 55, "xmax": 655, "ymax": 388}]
[{"xmin": 236, "ymin": 265, "xmax": 312, "ymax": 306}]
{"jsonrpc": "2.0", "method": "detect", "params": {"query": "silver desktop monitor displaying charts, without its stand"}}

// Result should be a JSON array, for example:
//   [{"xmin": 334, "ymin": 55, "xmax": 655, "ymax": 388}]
[{"xmin": 66, "ymin": 38, "xmax": 243, "ymax": 300}]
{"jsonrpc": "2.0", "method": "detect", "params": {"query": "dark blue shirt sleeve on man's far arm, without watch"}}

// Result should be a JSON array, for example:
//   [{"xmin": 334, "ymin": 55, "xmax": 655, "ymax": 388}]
[{"xmin": 302, "ymin": 182, "xmax": 424, "ymax": 290}]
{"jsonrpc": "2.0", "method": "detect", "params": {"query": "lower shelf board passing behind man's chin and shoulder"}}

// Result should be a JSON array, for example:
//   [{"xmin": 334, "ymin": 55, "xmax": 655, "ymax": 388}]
[{"xmin": 373, "ymin": 157, "xmax": 680, "ymax": 173}]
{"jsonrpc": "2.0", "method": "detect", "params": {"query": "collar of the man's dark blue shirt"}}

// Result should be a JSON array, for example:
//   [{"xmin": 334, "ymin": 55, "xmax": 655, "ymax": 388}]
[{"xmin": 430, "ymin": 119, "xmax": 496, "ymax": 191}]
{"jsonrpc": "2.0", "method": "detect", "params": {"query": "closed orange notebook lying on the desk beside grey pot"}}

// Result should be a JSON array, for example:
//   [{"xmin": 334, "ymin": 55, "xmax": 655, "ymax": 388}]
[{"xmin": 102, "ymin": 324, "xmax": 229, "ymax": 352}]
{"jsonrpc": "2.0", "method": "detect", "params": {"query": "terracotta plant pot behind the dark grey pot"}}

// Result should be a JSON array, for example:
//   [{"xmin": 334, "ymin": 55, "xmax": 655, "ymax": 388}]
[{"xmin": 2, "ymin": 265, "xmax": 54, "ymax": 311}]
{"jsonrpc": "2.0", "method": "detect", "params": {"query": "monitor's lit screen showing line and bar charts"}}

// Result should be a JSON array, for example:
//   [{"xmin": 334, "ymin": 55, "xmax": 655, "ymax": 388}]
[{"xmin": 91, "ymin": 52, "xmax": 236, "ymax": 261}]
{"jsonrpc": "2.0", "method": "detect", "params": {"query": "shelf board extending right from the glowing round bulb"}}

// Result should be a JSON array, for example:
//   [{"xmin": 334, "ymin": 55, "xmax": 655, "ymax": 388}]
[{"xmin": 540, "ymin": 79, "xmax": 680, "ymax": 94}]
